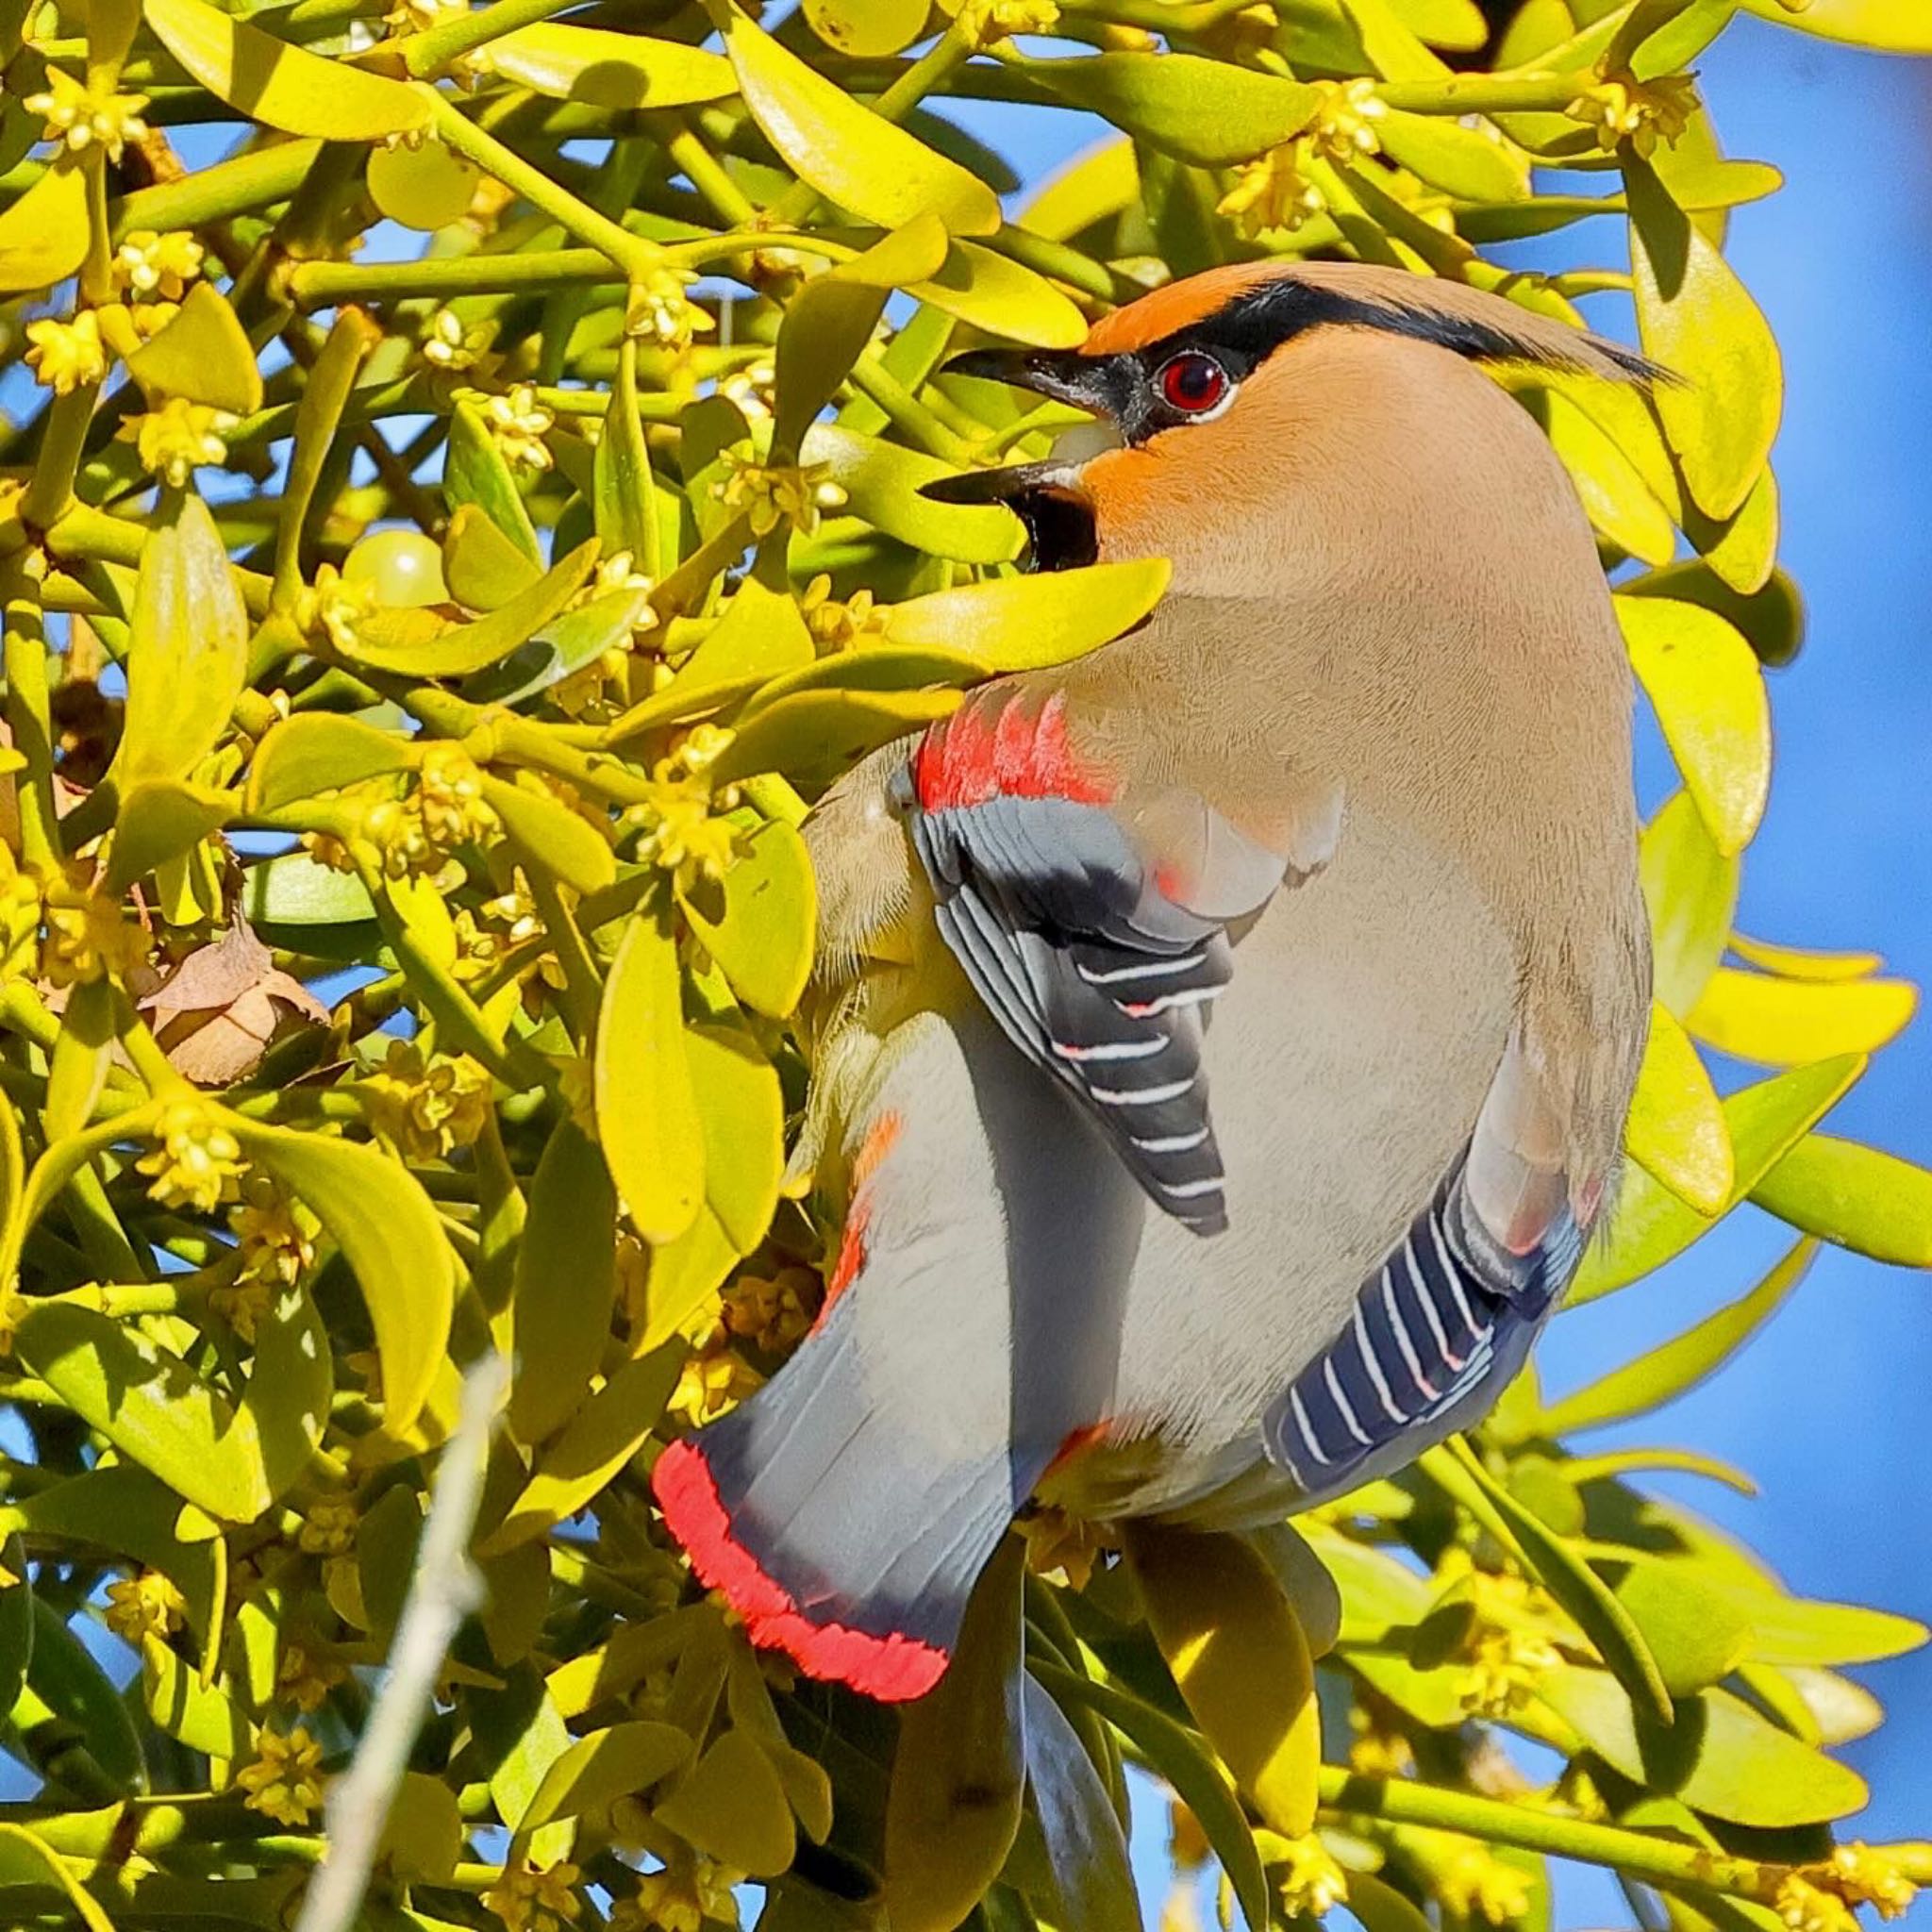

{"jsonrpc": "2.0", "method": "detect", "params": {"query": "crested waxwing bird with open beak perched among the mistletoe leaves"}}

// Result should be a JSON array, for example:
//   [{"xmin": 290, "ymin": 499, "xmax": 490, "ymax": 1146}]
[{"xmin": 653, "ymin": 260, "xmax": 1659, "ymax": 1702}]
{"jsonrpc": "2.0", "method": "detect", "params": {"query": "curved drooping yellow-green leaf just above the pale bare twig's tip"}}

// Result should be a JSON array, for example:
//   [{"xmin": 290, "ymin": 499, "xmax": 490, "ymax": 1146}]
[{"xmin": 225, "ymin": 1115, "xmax": 456, "ymax": 1438}]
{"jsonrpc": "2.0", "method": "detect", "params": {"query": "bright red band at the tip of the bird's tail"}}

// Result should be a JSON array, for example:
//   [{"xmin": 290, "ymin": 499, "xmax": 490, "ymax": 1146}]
[{"xmin": 651, "ymin": 1440, "xmax": 951, "ymax": 1704}]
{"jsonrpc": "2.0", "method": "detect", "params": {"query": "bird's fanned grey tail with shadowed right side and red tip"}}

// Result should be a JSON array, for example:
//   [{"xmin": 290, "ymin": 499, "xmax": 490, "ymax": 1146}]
[{"xmin": 653, "ymin": 1014, "xmax": 1138, "ymax": 1700}]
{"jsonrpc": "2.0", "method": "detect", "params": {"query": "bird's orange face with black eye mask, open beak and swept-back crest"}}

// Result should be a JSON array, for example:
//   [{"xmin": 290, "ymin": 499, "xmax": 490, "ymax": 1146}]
[{"xmin": 925, "ymin": 260, "xmax": 1657, "ymax": 570}]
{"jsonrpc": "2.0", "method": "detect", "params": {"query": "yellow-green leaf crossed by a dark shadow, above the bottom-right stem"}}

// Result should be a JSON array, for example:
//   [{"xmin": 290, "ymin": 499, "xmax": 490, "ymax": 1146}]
[{"xmin": 1538, "ymin": 1669, "xmax": 1866, "ymax": 1829}]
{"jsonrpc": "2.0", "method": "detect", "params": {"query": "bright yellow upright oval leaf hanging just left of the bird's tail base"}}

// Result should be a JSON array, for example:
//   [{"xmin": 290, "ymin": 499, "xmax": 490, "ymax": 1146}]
[{"xmin": 593, "ymin": 912, "xmax": 706, "ymax": 1244}]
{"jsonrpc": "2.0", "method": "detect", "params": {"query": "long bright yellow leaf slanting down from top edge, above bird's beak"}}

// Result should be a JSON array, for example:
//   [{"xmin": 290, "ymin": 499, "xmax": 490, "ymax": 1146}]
[{"xmin": 723, "ymin": 11, "xmax": 999, "ymax": 236}]
